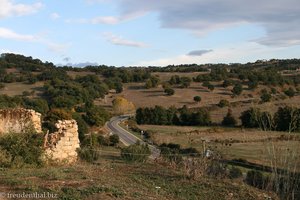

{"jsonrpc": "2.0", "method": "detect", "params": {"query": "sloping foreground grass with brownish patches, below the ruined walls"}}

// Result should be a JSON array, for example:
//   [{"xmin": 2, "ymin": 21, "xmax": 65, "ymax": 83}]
[{"xmin": 0, "ymin": 146, "xmax": 276, "ymax": 200}]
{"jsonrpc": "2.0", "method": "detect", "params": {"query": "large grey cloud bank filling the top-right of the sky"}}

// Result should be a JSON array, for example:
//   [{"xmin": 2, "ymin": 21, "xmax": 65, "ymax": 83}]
[{"xmin": 118, "ymin": 0, "xmax": 300, "ymax": 46}]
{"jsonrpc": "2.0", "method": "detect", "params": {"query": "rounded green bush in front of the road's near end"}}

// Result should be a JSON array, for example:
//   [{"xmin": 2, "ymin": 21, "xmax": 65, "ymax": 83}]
[{"xmin": 121, "ymin": 143, "xmax": 151, "ymax": 162}]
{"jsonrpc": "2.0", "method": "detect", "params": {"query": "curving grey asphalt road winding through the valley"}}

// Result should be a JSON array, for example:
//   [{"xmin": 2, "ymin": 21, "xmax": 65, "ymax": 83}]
[{"xmin": 107, "ymin": 115, "xmax": 160, "ymax": 158}]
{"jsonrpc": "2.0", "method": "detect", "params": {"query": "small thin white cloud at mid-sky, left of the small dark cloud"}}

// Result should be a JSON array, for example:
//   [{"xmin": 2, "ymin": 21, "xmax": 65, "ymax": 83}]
[{"xmin": 103, "ymin": 33, "xmax": 147, "ymax": 48}]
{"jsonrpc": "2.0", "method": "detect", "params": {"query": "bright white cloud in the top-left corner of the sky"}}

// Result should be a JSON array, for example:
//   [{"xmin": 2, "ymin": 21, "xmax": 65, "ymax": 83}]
[{"xmin": 0, "ymin": 0, "xmax": 43, "ymax": 19}]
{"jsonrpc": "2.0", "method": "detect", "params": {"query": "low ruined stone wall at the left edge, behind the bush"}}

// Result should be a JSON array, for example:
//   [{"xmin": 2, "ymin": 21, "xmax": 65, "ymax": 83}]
[{"xmin": 0, "ymin": 108, "xmax": 42, "ymax": 134}]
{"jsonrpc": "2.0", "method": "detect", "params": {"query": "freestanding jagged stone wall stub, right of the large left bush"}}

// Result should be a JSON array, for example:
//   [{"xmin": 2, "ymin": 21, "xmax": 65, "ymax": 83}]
[{"xmin": 44, "ymin": 120, "xmax": 80, "ymax": 163}]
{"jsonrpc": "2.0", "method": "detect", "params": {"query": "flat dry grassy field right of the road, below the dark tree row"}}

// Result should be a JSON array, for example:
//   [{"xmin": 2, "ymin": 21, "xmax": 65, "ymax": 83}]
[{"xmin": 139, "ymin": 125, "xmax": 300, "ymax": 169}]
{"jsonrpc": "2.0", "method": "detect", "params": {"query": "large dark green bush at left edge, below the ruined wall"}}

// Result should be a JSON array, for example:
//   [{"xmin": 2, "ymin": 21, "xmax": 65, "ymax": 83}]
[{"xmin": 0, "ymin": 132, "xmax": 43, "ymax": 167}]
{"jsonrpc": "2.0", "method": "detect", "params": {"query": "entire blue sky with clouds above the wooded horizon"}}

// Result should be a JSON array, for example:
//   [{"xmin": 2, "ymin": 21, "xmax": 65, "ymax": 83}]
[{"xmin": 0, "ymin": 0, "xmax": 300, "ymax": 67}]
